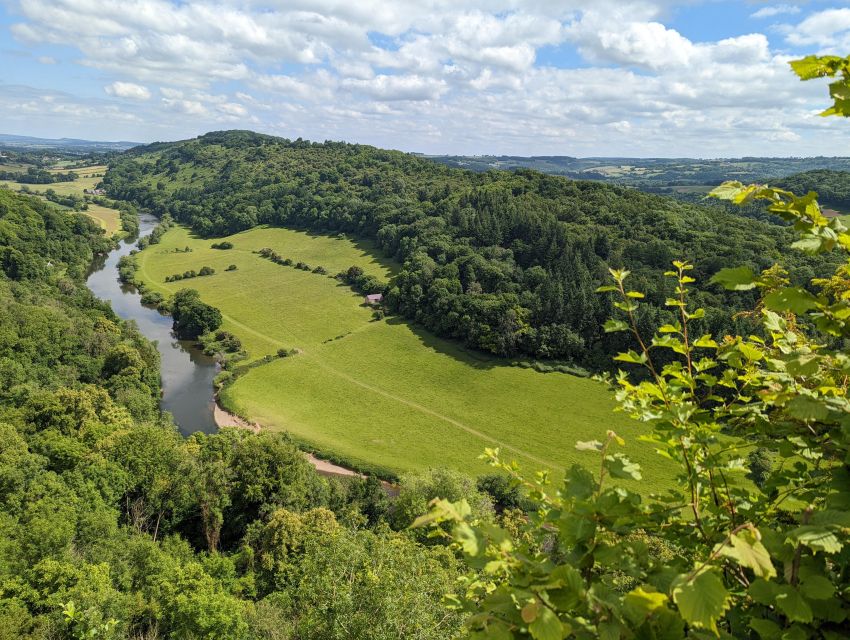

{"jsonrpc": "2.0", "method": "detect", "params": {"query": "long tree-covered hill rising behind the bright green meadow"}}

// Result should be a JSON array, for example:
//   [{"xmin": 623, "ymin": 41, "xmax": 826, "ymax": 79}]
[{"xmin": 104, "ymin": 131, "xmax": 836, "ymax": 367}]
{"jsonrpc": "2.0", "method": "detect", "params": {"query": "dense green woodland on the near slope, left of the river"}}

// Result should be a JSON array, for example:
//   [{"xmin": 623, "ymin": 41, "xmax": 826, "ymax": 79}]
[{"xmin": 0, "ymin": 189, "xmax": 506, "ymax": 640}]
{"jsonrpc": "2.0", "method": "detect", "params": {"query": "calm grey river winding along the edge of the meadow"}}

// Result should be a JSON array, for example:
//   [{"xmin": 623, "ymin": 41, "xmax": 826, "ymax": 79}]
[{"xmin": 86, "ymin": 214, "xmax": 218, "ymax": 435}]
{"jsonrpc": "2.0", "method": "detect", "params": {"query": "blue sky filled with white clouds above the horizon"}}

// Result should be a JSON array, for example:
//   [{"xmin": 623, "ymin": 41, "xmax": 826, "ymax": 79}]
[{"xmin": 0, "ymin": 0, "xmax": 850, "ymax": 157}]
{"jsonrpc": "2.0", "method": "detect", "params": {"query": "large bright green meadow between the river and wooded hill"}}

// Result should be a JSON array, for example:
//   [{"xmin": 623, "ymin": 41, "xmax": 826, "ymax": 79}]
[{"xmin": 139, "ymin": 227, "xmax": 669, "ymax": 487}]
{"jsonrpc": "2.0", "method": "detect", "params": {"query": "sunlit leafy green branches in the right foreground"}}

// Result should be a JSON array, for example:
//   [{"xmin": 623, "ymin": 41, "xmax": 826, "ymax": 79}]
[{"xmin": 416, "ymin": 58, "xmax": 850, "ymax": 640}]
